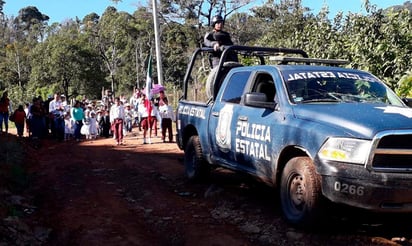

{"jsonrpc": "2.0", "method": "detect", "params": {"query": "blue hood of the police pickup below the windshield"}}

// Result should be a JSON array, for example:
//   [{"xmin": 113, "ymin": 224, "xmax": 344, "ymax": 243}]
[{"xmin": 293, "ymin": 103, "xmax": 412, "ymax": 139}]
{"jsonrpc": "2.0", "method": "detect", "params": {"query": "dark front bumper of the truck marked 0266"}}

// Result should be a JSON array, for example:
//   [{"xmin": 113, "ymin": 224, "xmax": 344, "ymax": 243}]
[{"xmin": 318, "ymin": 162, "xmax": 412, "ymax": 212}]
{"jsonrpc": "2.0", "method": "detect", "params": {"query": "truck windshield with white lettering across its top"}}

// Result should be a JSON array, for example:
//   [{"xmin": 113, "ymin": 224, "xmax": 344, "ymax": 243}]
[{"xmin": 283, "ymin": 70, "xmax": 403, "ymax": 106}]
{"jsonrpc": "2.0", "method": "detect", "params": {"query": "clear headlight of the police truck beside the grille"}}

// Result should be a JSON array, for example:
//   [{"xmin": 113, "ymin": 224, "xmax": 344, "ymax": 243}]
[{"xmin": 318, "ymin": 138, "xmax": 372, "ymax": 164}]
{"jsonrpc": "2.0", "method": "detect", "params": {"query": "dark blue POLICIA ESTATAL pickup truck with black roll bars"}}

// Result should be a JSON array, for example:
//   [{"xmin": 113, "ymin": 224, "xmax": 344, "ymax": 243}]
[{"xmin": 176, "ymin": 46, "xmax": 412, "ymax": 226}]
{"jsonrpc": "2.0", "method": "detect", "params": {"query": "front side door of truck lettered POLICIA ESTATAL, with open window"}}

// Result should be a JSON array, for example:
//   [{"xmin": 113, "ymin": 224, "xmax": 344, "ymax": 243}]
[{"xmin": 233, "ymin": 72, "xmax": 280, "ymax": 178}]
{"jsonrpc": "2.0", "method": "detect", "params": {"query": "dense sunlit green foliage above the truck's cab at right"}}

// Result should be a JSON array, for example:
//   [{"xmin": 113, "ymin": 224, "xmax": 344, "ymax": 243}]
[{"xmin": 249, "ymin": 1, "xmax": 412, "ymax": 89}]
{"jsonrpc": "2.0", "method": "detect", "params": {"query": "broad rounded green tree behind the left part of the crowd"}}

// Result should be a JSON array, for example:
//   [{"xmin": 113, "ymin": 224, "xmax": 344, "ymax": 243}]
[{"xmin": 31, "ymin": 22, "xmax": 104, "ymax": 98}]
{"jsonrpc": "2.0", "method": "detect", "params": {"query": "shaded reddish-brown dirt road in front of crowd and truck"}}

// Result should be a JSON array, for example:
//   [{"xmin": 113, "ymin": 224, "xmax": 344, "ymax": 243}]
[{"xmin": 3, "ymin": 129, "xmax": 412, "ymax": 246}]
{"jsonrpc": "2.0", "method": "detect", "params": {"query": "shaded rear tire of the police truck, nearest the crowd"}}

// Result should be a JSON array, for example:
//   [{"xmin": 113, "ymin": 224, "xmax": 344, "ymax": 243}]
[{"xmin": 184, "ymin": 136, "xmax": 210, "ymax": 181}]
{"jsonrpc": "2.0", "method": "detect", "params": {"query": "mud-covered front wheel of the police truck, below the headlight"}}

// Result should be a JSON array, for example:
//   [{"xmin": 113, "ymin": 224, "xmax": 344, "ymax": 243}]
[{"xmin": 279, "ymin": 157, "xmax": 323, "ymax": 227}]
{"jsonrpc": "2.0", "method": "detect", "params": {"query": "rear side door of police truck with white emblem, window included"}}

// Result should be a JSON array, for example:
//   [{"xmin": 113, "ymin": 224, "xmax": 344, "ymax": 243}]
[{"xmin": 208, "ymin": 71, "xmax": 251, "ymax": 166}]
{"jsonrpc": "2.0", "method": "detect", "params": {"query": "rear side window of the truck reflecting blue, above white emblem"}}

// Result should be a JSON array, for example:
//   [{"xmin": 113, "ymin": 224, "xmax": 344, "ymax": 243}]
[{"xmin": 222, "ymin": 71, "xmax": 250, "ymax": 103}]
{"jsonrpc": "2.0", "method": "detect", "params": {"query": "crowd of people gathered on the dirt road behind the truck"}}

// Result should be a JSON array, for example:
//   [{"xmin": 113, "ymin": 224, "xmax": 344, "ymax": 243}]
[{"xmin": 0, "ymin": 89, "xmax": 175, "ymax": 145}]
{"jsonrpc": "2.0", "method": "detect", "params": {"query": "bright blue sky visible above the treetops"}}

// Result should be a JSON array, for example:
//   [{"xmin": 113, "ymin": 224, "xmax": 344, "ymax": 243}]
[{"xmin": 3, "ymin": 0, "xmax": 407, "ymax": 24}]
